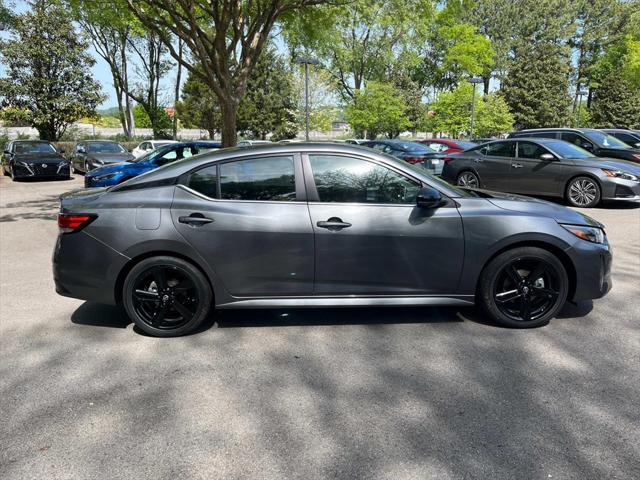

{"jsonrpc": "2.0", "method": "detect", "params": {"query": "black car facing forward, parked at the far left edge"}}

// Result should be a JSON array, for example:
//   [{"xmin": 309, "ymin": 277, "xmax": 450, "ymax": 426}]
[{"xmin": 2, "ymin": 140, "xmax": 71, "ymax": 182}]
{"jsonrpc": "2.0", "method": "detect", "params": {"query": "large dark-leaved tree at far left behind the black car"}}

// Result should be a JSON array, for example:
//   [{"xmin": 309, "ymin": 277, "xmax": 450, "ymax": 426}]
[{"xmin": 0, "ymin": 0, "xmax": 104, "ymax": 140}]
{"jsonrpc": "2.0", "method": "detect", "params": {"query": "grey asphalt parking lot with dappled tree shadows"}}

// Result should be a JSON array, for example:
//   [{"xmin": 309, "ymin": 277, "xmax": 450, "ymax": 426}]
[{"xmin": 0, "ymin": 177, "xmax": 640, "ymax": 480}]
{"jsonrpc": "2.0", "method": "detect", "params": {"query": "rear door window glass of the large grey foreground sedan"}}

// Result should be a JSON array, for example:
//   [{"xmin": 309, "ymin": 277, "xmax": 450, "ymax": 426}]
[{"xmin": 220, "ymin": 157, "xmax": 296, "ymax": 202}]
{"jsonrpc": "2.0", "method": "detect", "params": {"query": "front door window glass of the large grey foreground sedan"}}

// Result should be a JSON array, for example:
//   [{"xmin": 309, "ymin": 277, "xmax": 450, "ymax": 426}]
[{"xmin": 309, "ymin": 155, "xmax": 420, "ymax": 204}]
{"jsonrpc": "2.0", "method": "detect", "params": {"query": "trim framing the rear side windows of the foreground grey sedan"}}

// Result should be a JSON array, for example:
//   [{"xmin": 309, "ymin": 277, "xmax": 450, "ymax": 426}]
[{"xmin": 177, "ymin": 152, "xmax": 307, "ymax": 205}]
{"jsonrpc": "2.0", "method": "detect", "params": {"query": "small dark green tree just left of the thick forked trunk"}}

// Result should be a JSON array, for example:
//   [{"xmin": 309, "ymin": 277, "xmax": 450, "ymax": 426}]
[{"xmin": 176, "ymin": 65, "xmax": 222, "ymax": 139}]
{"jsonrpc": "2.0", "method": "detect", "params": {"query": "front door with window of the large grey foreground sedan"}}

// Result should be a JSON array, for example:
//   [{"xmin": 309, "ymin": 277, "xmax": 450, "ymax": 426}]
[{"xmin": 303, "ymin": 153, "xmax": 464, "ymax": 295}]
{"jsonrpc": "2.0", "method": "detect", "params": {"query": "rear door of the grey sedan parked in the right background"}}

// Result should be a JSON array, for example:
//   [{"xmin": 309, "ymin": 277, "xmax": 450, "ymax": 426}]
[{"xmin": 472, "ymin": 140, "xmax": 516, "ymax": 190}]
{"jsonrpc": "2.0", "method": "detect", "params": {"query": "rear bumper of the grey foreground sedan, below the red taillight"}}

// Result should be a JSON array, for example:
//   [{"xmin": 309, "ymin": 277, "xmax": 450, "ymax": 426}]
[{"xmin": 53, "ymin": 231, "xmax": 129, "ymax": 304}]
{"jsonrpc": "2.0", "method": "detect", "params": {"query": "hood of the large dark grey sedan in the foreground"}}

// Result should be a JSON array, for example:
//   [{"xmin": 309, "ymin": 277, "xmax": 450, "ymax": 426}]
[{"xmin": 474, "ymin": 190, "xmax": 604, "ymax": 228}]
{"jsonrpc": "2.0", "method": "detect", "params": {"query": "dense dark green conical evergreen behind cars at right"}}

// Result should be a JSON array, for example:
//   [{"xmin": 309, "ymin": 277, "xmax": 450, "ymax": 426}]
[{"xmin": 502, "ymin": 43, "xmax": 571, "ymax": 129}]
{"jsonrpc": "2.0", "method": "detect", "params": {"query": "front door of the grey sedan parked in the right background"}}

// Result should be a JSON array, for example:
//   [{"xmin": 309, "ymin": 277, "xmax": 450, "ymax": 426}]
[{"xmin": 507, "ymin": 141, "xmax": 565, "ymax": 195}]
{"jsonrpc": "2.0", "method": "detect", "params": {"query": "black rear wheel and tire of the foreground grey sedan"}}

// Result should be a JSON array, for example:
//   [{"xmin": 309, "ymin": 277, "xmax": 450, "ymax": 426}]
[{"xmin": 122, "ymin": 256, "xmax": 213, "ymax": 337}]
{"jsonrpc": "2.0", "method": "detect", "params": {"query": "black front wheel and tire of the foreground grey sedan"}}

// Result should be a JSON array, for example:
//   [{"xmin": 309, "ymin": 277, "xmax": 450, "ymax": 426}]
[{"xmin": 478, "ymin": 247, "xmax": 569, "ymax": 328}]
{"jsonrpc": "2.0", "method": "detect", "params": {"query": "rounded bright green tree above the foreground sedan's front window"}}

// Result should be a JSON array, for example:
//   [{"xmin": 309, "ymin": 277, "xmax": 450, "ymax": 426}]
[{"xmin": 346, "ymin": 82, "xmax": 410, "ymax": 139}]
